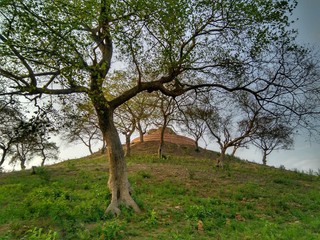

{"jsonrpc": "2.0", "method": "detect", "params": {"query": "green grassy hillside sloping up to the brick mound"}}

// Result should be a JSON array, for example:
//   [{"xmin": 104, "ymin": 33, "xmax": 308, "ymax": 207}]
[{"xmin": 0, "ymin": 143, "xmax": 320, "ymax": 240}]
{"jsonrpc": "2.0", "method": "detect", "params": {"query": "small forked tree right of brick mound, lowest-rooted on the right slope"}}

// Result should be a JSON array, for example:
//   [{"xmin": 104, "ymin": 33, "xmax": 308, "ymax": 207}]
[{"xmin": 204, "ymin": 94, "xmax": 262, "ymax": 167}]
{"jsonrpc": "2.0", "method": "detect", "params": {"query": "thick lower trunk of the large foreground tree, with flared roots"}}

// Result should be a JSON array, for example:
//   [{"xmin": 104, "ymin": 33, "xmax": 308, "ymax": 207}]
[{"xmin": 97, "ymin": 108, "xmax": 140, "ymax": 215}]
